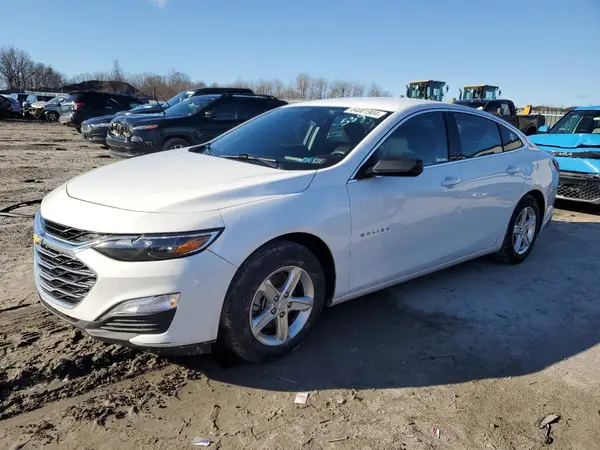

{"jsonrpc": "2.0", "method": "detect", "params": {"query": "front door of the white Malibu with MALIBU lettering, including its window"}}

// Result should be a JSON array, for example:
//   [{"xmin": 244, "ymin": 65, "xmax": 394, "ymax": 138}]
[{"xmin": 347, "ymin": 111, "xmax": 465, "ymax": 291}]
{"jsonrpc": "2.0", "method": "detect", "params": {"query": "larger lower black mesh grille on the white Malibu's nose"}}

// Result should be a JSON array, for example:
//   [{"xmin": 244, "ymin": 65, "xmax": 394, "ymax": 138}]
[{"xmin": 35, "ymin": 243, "xmax": 96, "ymax": 306}]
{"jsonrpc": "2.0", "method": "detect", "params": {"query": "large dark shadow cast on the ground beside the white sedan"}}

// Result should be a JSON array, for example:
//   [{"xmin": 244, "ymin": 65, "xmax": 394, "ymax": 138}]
[{"xmin": 171, "ymin": 217, "xmax": 600, "ymax": 391}]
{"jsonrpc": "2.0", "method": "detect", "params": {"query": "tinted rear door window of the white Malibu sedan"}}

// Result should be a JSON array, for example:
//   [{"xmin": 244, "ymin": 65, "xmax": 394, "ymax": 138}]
[{"xmin": 452, "ymin": 112, "xmax": 502, "ymax": 158}]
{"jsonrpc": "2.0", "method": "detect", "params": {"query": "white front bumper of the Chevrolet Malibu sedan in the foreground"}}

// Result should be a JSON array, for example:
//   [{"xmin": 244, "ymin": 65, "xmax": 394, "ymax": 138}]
[{"xmin": 34, "ymin": 199, "xmax": 237, "ymax": 354}]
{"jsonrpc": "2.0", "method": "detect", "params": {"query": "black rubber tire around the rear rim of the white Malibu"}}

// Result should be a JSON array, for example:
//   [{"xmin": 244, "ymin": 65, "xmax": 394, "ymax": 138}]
[{"xmin": 494, "ymin": 194, "xmax": 544, "ymax": 264}]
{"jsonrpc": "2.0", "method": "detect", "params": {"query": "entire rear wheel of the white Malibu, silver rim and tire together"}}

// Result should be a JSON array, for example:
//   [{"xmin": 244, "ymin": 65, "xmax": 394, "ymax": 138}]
[{"xmin": 495, "ymin": 195, "xmax": 543, "ymax": 264}]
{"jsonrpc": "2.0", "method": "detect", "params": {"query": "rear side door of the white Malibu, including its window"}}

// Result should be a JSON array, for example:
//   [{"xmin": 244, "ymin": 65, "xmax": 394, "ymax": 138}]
[{"xmin": 448, "ymin": 112, "xmax": 525, "ymax": 253}]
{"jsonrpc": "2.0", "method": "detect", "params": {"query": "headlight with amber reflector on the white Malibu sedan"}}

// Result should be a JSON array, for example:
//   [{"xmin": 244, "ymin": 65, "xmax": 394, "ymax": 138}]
[{"xmin": 93, "ymin": 228, "xmax": 223, "ymax": 261}]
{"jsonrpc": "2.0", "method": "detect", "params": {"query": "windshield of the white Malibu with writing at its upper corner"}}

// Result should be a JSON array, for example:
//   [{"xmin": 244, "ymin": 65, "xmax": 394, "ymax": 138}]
[{"xmin": 192, "ymin": 106, "xmax": 390, "ymax": 170}]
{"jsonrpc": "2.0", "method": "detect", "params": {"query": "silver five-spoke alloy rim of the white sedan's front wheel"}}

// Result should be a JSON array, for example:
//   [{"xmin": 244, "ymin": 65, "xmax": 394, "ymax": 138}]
[{"xmin": 250, "ymin": 266, "xmax": 315, "ymax": 346}]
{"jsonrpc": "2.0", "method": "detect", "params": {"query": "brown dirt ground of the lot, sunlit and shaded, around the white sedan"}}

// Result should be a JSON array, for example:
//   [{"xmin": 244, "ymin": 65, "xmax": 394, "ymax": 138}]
[{"xmin": 0, "ymin": 122, "xmax": 600, "ymax": 450}]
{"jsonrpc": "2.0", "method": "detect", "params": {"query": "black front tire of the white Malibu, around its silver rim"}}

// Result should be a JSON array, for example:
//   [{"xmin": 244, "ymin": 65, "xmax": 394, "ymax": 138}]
[{"xmin": 219, "ymin": 240, "xmax": 325, "ymax": 363}]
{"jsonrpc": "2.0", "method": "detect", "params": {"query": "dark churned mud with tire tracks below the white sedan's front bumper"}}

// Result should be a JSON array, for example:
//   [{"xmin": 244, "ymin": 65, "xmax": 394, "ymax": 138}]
[{"xmin": 0, "ymin": 308, "xmax": 169, "ymax": 420}]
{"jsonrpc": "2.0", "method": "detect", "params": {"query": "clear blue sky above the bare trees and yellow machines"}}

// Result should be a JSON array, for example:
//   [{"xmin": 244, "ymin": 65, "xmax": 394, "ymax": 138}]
[{"xmin": 0, "ymin": 0, "xmax": 600, "ymax": 106}]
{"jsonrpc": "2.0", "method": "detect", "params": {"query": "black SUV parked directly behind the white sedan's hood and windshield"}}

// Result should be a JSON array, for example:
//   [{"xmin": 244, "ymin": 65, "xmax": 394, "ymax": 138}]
[{"xmin": 106, "ymin": 94, "xmax": 287, "ymax": 158}]
